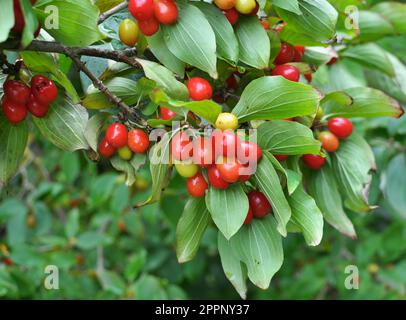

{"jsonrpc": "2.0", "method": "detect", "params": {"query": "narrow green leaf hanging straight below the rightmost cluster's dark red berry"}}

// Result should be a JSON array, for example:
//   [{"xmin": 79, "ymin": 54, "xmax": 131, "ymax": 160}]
[{"xmin": 308, "ymin": 166, "xmax": 356, "ymax": 239}]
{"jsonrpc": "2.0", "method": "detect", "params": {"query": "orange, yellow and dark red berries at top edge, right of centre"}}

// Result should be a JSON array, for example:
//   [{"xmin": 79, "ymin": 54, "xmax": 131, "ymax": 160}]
[{"xmin": 219, "ymin": 0, "xmax": 259, "ymax": 25}]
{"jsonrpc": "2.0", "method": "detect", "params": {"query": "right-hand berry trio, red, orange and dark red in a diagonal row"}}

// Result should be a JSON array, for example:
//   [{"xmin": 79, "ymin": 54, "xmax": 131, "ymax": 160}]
[{"xmin": 302, "ymin": 117, "xmax": 352, "ymax": 170}]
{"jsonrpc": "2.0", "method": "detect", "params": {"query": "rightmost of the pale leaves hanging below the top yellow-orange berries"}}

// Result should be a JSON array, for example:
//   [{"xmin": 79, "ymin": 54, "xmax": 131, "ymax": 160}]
[{"xmin": 235, "ymin": 16, "xmax": 271, "ymax": 69}]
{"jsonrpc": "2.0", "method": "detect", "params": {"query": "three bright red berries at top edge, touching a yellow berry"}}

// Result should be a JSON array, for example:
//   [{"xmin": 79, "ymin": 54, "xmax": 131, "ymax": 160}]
[{"xmin": 128, "ymin": 0, "xmax": 179, "ymax": 36}]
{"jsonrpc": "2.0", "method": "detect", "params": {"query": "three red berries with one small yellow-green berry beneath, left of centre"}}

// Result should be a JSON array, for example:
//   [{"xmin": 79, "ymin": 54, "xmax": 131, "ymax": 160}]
[{"xmin": 99, "ymin": 122, "xmax": 150, "ymax": 161}]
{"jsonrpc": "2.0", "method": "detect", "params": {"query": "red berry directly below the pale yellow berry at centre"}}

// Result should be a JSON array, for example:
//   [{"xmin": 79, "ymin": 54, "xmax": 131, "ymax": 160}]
[{"xmin": 211, "ymin": 130, "xmax": 241, "ymax": 159}]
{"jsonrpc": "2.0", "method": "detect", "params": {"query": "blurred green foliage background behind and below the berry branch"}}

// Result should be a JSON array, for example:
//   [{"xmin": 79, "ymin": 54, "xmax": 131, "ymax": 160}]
[{"xmin": 0, "ymin": 110, "xmax": 406, "ymax": 299}]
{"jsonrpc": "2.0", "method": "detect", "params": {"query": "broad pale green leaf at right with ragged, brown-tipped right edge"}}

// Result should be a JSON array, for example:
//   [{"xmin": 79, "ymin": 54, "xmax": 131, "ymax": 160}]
[{"xmin": 332, "ymin": 133, "xmax": 375, "ymax": 212}]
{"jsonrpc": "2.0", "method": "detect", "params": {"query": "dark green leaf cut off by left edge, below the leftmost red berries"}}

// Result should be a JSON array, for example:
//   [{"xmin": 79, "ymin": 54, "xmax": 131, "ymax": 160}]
[{"xmin": 0, "ymin": 114, "xmax": 28, "ymax": 183}]
